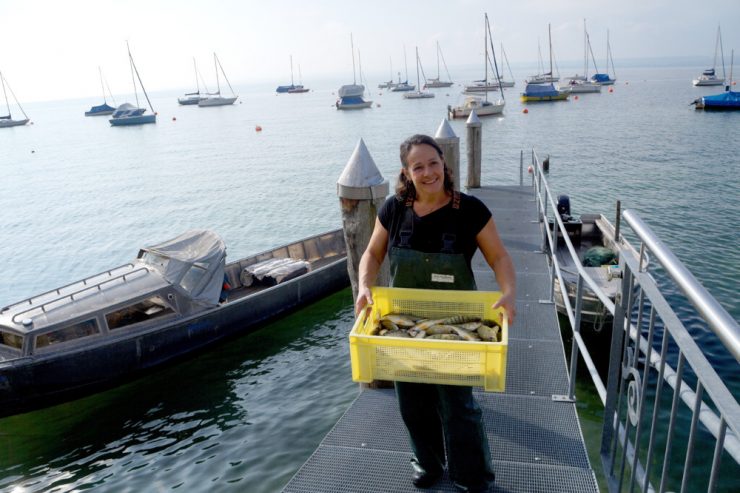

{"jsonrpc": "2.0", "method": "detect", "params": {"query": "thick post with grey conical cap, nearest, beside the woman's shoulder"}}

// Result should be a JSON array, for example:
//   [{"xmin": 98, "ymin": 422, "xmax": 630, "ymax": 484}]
[{"xmin": 337, "ymin": 139, "xmax": 390, "ymax": 300}]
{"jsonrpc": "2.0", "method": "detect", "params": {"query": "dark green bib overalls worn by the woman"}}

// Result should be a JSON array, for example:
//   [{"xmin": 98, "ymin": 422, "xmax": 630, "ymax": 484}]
[{"xmin": 389, "ymin": 192, "xmax": 495, "ymax": 491}]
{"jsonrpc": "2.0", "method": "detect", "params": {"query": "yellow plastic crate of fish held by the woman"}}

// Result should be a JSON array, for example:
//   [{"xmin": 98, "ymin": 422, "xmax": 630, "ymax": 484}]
[{"xmin": 349, "ymin": 287, "xmax": 509, "ymax": 392}]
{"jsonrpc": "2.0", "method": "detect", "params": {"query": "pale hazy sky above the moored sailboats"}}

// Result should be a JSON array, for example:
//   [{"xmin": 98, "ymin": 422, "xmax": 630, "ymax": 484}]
[{"xmin": 0, "ymin": 0, "xmax": 740, "ymax": 104}]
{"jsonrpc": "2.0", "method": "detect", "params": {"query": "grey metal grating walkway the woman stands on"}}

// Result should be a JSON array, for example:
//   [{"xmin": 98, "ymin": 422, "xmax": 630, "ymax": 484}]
[{"xmin": 283, "ymin": 186, "xmax": 598, "ymax": 493}]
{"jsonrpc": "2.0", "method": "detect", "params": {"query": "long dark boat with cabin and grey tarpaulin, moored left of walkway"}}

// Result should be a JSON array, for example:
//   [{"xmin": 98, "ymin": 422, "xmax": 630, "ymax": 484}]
[{"xmin": 0, "ymin": 230, "xmax": 349, "ymax": 416}]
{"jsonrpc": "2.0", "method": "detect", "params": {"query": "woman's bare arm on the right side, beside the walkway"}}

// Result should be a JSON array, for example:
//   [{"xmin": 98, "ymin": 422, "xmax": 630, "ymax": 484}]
[{"xmin": 475, "ymin": 218, "xmax": 516, "ymax": 325}]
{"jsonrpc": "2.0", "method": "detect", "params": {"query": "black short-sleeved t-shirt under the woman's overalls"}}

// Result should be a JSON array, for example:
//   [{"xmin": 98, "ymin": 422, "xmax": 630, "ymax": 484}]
[{"xmin": 378, "ymin": 193, "xmax": 491, "ymax": 265}]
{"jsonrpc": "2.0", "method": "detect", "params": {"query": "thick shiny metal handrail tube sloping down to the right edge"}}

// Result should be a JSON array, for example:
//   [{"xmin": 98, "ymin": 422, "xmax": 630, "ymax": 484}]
[{"xmin": 623, "ymin": 210, "xmax": 740, "ymax": 362}]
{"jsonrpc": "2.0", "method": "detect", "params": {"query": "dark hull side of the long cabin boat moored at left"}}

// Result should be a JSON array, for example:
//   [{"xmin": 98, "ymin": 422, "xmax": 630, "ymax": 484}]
[{"xmin": 0, "ymin": 238, "xmax": 349, "ymax": 416}]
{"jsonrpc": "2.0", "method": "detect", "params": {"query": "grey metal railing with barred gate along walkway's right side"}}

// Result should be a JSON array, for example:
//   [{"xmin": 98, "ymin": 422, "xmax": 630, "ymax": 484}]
[{"xmin": 520, "ymin": 151, "xmax": 740, "ymax": 493}]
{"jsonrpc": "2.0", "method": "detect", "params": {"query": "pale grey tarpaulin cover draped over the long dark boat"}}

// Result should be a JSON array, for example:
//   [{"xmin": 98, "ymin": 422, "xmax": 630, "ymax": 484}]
[{"xmin": 138, "ymin": 230, "xmax": 226, "ymax": 305}]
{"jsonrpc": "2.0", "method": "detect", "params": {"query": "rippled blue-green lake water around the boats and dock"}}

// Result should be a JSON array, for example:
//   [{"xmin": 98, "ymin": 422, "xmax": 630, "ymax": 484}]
[{"xmin": 0, "ymin": 63, "xmax": 740, "ymax": 493}]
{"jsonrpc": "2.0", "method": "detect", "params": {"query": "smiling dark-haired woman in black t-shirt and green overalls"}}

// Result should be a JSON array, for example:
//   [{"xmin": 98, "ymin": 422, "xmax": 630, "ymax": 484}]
[{"xmin": 355, "ymin": 135, "xmax": 516, "ymax": 493}]
